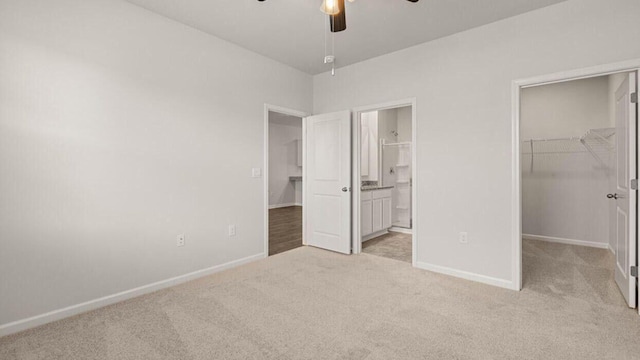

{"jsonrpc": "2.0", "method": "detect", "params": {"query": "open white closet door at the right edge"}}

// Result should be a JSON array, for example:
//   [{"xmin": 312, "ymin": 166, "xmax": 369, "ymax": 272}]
[{"xmin": 608, "ymin": 73, "xmax": 637, "ymax": 307}]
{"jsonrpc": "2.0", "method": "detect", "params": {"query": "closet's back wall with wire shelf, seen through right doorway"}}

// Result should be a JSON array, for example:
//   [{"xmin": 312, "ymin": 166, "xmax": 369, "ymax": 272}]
[{"xmin": 520, "ymin": 76, "xmax": 615, "ymax": 247}]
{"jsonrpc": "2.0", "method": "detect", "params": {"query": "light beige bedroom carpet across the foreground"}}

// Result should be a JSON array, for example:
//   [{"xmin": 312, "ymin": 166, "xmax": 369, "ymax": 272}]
[{"xmin": 0, "ymin": 240, "xmax": 640, "ymax": 360}]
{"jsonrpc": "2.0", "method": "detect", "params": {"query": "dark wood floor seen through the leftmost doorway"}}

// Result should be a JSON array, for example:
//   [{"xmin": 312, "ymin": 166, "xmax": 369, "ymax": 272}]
[{"xmin": 269, "ymin": 206, "xmax": 302, "ymax": 256}]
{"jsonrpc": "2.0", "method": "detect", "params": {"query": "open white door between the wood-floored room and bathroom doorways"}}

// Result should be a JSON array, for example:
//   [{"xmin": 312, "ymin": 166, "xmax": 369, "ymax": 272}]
[{"xmin": 305, "ymin": 111, "xmax": 351, "ymax": 254}]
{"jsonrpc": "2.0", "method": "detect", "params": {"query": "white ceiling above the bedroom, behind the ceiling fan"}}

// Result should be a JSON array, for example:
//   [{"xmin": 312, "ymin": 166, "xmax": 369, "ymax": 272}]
[{"xmin": 127, "ymin": 0, "xmax": 565, "ymax": 74}]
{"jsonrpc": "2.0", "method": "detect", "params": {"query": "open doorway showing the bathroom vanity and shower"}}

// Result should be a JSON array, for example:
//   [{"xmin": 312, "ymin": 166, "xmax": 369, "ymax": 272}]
[{"xmin": 357, "ymin": 106, "xmax": 414, "ymax": 263}]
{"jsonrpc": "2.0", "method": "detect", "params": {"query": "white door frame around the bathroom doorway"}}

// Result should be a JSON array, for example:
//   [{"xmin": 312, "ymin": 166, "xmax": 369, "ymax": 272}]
[{"xmin": 351, "ymin": 97, "xmax": 418, "ymax": 267}]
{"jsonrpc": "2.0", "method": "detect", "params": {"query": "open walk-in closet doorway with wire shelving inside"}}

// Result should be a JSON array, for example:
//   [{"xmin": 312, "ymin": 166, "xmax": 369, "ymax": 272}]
[{"xmin": 516, "ymin": 70, "xmax": 637, "ymax": 308}]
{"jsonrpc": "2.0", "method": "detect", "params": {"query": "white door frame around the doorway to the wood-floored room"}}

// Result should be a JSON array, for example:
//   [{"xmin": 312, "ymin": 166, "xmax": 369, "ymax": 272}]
[{"xmin": 262, "ymin": 103, "xmax": 309, "ymax": 258}]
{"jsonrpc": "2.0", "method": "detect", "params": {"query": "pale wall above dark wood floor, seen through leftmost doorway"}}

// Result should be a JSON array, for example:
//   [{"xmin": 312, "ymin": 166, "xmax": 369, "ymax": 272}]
[{"xmin": 269, "ymin": 118, "xmax": 302, "ymax": 205}]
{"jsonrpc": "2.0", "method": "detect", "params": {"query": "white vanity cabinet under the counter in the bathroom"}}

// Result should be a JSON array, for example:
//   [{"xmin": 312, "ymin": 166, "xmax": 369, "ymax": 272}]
[{"xmin": 360, "ymin": 189, "xmax": 391, "ymax": 238}]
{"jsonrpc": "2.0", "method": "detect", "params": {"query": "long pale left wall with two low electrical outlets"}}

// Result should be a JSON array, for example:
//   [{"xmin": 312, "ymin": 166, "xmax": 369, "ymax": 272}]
[{"xmin": 0, "ymin": 0, "xmax": 312, "ymax": 324}]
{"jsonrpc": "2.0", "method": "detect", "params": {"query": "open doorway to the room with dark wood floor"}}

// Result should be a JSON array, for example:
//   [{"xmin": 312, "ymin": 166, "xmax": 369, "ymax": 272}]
[{"xmin": 266, "ymin": 110, "xmax": 304, "ymax": 256}]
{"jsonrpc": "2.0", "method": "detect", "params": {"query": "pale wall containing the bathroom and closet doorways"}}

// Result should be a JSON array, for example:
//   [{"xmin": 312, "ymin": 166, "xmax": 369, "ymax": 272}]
[{"xmin": 314, "ymin": 0, "xmax": 640, "ymax": 287}]
